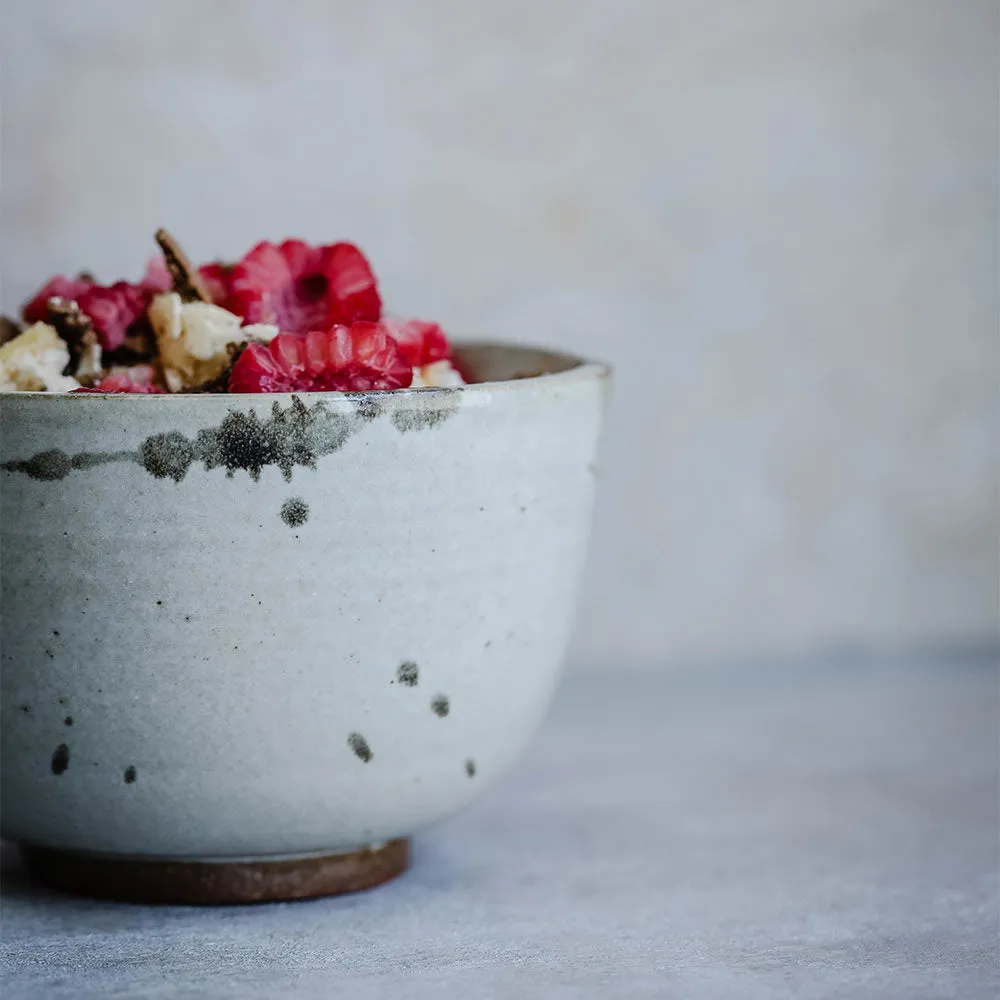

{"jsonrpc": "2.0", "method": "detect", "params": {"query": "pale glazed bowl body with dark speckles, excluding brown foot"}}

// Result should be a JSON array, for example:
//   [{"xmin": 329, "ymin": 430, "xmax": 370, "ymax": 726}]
[{"xmin": 0, "ymin": 345, "xmax": 608, "ymax": 860}]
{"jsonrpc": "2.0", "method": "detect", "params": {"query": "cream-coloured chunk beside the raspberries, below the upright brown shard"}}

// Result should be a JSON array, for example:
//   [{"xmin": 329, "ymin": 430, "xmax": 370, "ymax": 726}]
[{"xmin": 149, "ymin": 292, "xmax": 278, "ymax": 392}]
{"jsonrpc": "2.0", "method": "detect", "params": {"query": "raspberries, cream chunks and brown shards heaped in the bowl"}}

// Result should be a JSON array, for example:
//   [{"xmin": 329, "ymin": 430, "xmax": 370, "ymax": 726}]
[{"xmin": 0, "ymin": 229, "xmax": 464, "ymax": 394}]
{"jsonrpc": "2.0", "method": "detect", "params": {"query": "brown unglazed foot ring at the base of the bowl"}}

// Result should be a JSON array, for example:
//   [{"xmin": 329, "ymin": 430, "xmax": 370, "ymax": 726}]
[{"xmin": 21, "ymin": 839, "xmax": 410, "ymax": 906}]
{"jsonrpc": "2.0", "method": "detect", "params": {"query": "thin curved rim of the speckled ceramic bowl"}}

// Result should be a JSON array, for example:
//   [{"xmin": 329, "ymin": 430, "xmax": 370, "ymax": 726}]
[{"xmin": 0, "ymin": 340, "xmax": 613, "ymax": 406}]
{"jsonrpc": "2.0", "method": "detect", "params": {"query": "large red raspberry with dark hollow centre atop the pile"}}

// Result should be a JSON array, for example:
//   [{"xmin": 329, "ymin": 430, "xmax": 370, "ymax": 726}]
[{"xmin": 225, "ymin": 240, "xmax": 382, "ymax": 333}]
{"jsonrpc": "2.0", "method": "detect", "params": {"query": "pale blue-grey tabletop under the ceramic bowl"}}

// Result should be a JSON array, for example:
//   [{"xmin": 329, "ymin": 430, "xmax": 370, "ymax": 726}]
[{"xmin": 2, "ymin": 652, "xmax": 1000, "ymax": 1000}]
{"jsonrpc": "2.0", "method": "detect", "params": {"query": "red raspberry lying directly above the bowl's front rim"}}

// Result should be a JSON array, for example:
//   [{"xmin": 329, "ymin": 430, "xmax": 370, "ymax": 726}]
[{"xmin": 229, "ymin": 322, "xmax": 413, "ymax": 392}]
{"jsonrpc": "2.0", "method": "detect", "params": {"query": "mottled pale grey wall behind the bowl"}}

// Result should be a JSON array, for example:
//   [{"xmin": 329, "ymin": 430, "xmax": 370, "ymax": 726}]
[{"xmin": 0, "ymin": 0, "xmax": 1000, "ymax": 665}]
